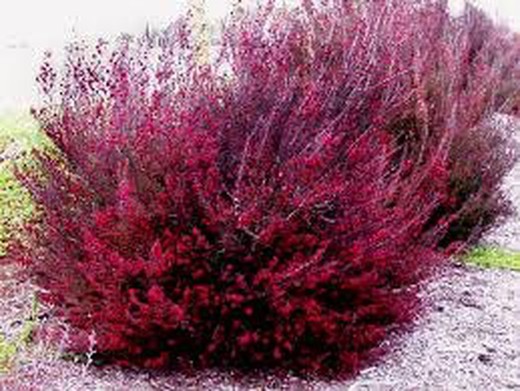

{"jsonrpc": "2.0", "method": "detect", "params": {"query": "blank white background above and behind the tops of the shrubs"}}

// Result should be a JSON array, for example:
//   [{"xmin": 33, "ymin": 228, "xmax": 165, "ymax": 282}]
[{"xmin": 0, "ymin": 0, "xmax": 520, "ymax": 110}]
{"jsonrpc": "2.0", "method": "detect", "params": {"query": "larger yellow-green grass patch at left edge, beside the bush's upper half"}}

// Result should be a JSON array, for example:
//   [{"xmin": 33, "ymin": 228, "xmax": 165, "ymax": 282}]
[{"xmin": 0, "ymin": 112, "xmax": 48, "ymax": 257}]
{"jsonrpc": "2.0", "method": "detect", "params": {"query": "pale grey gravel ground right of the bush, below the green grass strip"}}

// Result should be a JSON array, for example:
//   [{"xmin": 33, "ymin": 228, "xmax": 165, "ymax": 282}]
[{"xmin": 336, "ymin": 267, "xmax": 520, "ymax": 390}]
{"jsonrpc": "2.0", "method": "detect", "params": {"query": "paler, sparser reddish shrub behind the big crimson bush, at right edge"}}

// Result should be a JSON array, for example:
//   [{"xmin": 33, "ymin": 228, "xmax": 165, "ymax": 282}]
[{"xmin": 434, "ymin": 7, "xmax": 520, "ymax": 246}]
